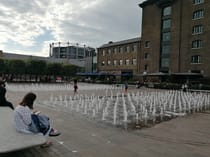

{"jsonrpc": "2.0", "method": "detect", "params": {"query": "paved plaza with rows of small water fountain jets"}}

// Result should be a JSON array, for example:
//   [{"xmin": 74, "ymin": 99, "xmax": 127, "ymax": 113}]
[{"xmin": 0, "ymin": 83, "xmax": 210, "ymax": 157}]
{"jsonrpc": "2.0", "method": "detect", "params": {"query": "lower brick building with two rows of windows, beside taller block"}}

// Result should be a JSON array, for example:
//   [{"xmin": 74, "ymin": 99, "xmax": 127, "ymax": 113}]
[{"xmin": 97, "ymin": 38, "xmax": 140, "ymax": 77}]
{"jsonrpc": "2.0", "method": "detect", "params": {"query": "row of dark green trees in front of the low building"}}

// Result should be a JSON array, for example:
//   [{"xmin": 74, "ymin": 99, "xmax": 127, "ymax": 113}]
[{"xmin": 0, "ymin": 59, "xmax": 81, "ymax": 77}]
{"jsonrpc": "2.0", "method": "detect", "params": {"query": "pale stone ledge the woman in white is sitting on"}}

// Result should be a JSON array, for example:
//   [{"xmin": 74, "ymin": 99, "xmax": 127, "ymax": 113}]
[{"xmin": 0, "ymin": 107, "xmax": 46, "ymax": 153}]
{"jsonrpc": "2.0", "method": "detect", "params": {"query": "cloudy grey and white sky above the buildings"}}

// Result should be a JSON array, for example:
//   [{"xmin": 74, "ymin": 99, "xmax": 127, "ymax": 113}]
[{"xmin": 0, "ymin": 0, "xmax": 144, "ymax": 56}]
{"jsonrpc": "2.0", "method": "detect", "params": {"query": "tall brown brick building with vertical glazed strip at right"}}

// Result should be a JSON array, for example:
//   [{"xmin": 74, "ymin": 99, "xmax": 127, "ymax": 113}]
[{"xmin": 138, "ymin": 0, "xmax": 210, "ymax": 77}]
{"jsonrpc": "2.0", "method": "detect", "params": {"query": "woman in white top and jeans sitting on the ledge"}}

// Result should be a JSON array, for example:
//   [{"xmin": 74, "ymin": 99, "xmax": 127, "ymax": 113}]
[{"xmin": 14, "ymin": 93, "xmax": 60, "ymax": 145}]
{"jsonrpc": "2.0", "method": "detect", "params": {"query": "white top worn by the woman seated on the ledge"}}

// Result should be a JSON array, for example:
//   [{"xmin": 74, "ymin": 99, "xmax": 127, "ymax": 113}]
[{"xmin": 14, "ymin": 105, "xmax": 32, "ymax": 133}]
